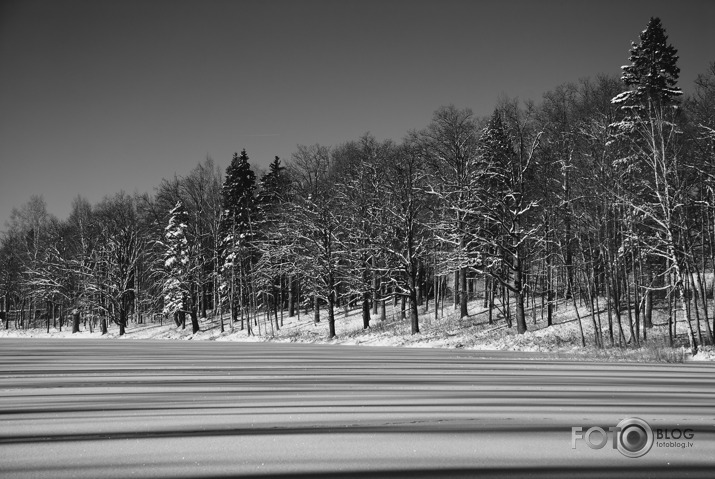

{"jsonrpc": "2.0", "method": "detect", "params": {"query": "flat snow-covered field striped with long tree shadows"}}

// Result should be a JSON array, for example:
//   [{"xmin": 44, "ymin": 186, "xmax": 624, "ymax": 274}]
[{"xmin": 0, "ymin": 339, "xmax": 715, "ymax": 478}]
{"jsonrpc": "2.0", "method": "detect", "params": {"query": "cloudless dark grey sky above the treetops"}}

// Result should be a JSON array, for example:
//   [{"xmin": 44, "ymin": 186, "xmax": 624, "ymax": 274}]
[{"xmin": 0, "ymin": 0, "xmax": 715, "ymax": 230}]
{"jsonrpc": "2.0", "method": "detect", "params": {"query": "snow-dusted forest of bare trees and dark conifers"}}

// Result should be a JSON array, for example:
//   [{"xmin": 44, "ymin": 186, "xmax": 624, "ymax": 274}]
[{"xmin": 0, "ymin": 18, "xmax": 715, "ymax": 353}]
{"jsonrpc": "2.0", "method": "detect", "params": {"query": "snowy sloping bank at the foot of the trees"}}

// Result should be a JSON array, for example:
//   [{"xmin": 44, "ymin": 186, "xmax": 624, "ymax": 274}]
[{"xmin": 0, "ymin": 302, "xmax": 715, "ymax": 362}]
